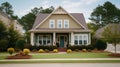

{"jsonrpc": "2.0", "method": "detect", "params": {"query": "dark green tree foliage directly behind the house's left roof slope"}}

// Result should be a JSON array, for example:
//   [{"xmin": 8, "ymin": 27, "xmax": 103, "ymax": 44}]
[{"xmin": 20, "ymin": 6, "xmax": 54, "ymax": 31}]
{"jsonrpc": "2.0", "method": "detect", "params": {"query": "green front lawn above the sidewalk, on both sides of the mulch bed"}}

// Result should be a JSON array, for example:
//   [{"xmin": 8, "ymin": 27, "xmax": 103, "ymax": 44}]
[{"xmin": 0, "ymin": 52, "xmax": 116, "ymax": 59}]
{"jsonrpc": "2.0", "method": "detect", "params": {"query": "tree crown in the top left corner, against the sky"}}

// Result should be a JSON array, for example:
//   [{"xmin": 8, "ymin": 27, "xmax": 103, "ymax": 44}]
[{"xmin": 0, "ymin": 2, "xmax": 13, "ymax": 16}]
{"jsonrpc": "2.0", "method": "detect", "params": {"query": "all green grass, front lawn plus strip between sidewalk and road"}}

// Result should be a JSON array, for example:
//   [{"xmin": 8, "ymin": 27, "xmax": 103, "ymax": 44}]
[{"xmin": 0, "ymin": 52, "xmax": 120, "ymax": 64}]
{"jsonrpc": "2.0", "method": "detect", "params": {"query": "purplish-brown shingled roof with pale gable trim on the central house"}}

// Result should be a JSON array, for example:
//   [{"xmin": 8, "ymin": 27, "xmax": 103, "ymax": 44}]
[{"xmin": 32, "ymin": 6, "xmax": 88, "ymax": 30}]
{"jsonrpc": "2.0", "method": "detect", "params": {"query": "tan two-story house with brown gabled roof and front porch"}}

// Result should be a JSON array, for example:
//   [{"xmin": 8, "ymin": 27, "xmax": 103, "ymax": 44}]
[{"xmin": 30, "ymin": 6, "xmax": 91, "ymax": 47}]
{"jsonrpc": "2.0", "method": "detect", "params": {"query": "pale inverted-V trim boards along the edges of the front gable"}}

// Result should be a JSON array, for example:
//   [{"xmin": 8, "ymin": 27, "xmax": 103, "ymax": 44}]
[{"xmin": 34, "ymin": 6, "xmax": 86, "ymax": 29}]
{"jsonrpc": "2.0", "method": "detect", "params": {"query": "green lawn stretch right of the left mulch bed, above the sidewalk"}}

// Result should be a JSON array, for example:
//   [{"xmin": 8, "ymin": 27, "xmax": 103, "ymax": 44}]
[{"xmin": 32, "ymin": 52, "xmax": 113, "ymax": 59}]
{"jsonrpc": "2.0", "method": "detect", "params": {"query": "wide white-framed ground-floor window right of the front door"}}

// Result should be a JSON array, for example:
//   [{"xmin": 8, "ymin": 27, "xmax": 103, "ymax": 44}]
[{"xmin": 74, "ymin": 34, "xmax": 88, "ymax": 45}]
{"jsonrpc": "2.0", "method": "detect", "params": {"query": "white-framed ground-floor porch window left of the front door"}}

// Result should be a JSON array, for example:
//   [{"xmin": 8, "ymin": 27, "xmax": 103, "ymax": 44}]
[{"xmin": 38, "ymin": 35, "xmax": 51, "ymax": 45}]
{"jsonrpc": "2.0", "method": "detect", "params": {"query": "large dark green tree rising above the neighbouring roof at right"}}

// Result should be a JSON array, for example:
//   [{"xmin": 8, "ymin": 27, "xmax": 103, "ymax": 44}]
[{"xmin": 89, "ymin": 1, "xmax": 120, "ymax": 28}]
